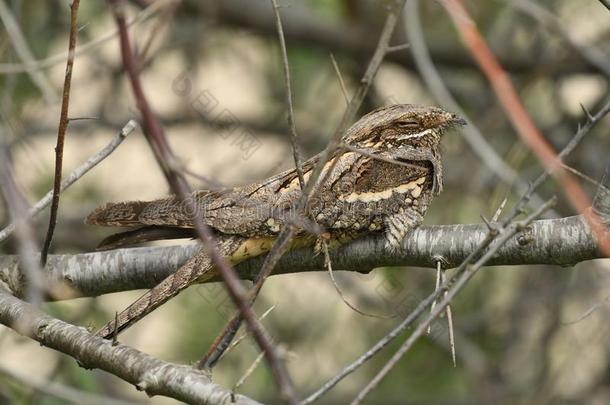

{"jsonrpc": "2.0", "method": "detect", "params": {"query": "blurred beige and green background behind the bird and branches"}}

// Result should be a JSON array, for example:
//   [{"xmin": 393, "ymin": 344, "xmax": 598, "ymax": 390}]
[{"xmin": 0, "ymin": 0, "xmax": 610, "ymax": 404}]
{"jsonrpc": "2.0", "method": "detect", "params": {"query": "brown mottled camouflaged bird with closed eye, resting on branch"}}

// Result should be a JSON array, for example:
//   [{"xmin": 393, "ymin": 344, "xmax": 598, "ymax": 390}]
[{"xmin": 86, "ymin": 104, "xmax": 465, "ymax": 338}]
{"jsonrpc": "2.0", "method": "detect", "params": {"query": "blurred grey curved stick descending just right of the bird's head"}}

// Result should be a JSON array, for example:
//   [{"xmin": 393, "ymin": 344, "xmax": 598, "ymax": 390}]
[{"xmin": 403, "ymin": 0, "xmax": 543, "ymax": 213}]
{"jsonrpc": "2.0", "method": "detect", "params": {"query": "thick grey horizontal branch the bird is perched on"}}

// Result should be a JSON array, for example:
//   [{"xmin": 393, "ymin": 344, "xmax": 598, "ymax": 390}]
[{"xmin": 0, "ymin": 216, "xmax": 610, "ymax": 296}]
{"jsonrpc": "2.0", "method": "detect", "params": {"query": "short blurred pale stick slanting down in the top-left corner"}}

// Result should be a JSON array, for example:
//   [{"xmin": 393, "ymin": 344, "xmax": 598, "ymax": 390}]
[{"xmin": 0, "ymin": 0, "xmax": 57, "ymax": 104}]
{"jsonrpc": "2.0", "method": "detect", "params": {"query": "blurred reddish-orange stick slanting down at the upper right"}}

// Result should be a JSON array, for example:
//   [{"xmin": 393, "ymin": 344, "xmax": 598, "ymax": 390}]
[{"xmin": 442, "ymin": 0, "xmax": 610, "ymax": 257}]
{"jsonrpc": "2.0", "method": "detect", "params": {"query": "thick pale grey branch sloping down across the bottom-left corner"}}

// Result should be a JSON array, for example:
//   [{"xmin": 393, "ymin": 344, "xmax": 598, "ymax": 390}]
[{"xmin": 0, "ymin": 289, "xmax": 257, "ymax": 404}]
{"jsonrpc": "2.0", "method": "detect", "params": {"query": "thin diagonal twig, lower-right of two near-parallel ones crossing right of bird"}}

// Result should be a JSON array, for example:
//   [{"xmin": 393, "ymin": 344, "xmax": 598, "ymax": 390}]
[{"xmin": 350, "ymin": 198, "xmax": 555, "ymax": 405}]
